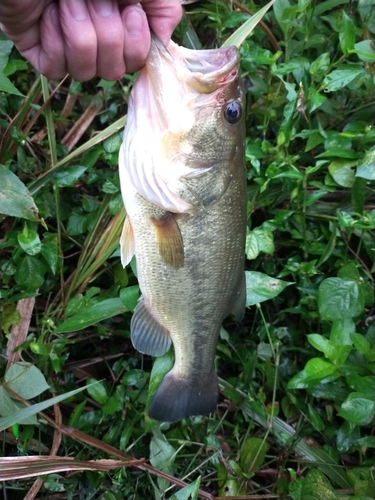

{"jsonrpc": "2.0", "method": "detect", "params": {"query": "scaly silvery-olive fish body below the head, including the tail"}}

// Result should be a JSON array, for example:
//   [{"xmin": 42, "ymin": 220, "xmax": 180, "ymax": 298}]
[{"xmin": 125, "ymin": 168, "xmax": 246, "ymax": 422}]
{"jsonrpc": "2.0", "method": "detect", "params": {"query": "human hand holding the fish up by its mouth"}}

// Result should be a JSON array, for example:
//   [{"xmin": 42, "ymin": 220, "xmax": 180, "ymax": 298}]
[{"xmin": 0, "ymin": 0, "xmax": 181, "ymax": 81}]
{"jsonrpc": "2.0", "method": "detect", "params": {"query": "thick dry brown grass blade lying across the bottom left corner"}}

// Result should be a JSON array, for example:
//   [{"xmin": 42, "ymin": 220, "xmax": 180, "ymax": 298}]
[{"xmin": 0, "ymin": 456, "xmax": 144, "ymax": 481}]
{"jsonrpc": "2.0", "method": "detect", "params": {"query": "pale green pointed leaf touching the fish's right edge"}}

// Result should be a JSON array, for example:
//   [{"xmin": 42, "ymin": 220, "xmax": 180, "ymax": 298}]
[{"xmin": 245, "ymin": 271, "xmax": 292, "ymax": 307}]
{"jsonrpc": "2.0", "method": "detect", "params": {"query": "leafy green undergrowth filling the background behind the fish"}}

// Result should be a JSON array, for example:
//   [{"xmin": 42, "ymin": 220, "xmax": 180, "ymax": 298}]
[{"xmin": 0, "ymin": 0, "xmax": 375, "ymax": 500}]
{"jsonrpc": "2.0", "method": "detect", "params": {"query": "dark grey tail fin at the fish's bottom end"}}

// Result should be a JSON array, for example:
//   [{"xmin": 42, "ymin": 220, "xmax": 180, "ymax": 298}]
[{"xmin": 148, "ymin": 370, "xmax": 219, "ymax": 422}]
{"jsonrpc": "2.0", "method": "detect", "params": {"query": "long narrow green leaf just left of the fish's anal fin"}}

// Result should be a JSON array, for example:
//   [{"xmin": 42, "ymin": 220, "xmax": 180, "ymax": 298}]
[{"xmin": 55, "ymin": 298, "xmax": 127, "ymax": 333}]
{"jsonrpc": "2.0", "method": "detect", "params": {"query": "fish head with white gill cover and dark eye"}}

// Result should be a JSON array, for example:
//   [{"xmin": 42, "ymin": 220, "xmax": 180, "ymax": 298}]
[{"xmin": 124, "ymin": 37, "xmax": 245, "ymax": 213}]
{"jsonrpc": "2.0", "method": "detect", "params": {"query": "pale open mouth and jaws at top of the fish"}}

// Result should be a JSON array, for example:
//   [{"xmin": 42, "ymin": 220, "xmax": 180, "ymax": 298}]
[{"xmin": 149, "ymin": 35, "xmax": 240, "ymax": 94}]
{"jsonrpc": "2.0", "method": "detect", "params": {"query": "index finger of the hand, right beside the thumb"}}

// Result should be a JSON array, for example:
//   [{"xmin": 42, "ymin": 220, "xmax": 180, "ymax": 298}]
[{"xmin": 122, "ymin": 4, "xmax": 151, "ymax": 72}]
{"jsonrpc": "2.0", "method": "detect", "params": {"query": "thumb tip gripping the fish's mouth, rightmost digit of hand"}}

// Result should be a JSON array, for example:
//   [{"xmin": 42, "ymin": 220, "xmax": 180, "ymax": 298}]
[{"xmin": 142, "ymin": 0, "xmax": 182, "ymax": 45}]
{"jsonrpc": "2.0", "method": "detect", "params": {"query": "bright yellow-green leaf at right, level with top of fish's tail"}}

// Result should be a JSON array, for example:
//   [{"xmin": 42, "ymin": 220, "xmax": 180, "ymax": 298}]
[{"xmin": 288, "ymin": 358, "xmax": 340, "ymax": 389}]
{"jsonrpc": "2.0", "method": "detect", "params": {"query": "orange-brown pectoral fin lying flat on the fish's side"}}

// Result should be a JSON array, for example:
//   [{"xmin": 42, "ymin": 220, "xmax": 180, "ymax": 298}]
[{"xmin": 151, "ymin": 212, "xmax": 184, "ymax": 269}]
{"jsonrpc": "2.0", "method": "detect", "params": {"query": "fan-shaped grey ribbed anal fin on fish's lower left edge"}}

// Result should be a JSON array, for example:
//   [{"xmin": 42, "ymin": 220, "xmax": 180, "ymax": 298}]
[{"xmin": 130, "ymin": 298, "xmax": 172, "ymax": 356}]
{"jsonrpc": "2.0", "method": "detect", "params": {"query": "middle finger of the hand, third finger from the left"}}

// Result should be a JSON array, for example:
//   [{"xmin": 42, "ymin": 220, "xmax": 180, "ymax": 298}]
[{"xmin": 87, "ymin": 0, "xmax": 125, "ymax": 80}]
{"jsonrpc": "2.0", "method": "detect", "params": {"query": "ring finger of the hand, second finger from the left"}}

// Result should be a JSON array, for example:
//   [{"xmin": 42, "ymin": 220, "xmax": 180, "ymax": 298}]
[{"xmin": 59, "ymin": 0, "xmax": 98, "ymax": 82}]
